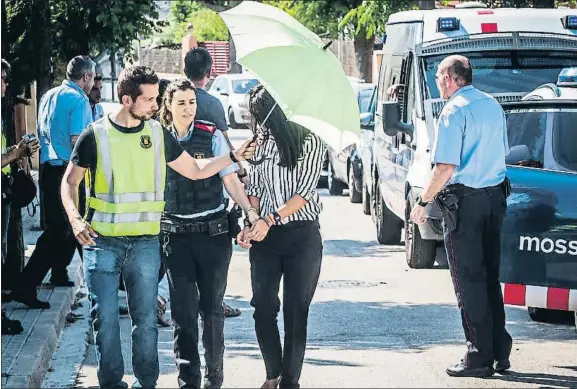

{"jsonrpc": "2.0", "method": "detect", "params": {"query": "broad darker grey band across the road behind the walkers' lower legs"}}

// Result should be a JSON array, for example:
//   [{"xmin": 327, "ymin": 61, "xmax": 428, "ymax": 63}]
[{"xmin": 218, "ymin": 298, "xmax": 575, "ymax": 364}]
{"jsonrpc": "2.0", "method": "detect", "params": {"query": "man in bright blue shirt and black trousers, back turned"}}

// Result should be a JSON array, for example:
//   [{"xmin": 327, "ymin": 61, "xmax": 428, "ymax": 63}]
[{"xmin": 11, "ymin": 56, "xmax": 96, "ymax": 309}]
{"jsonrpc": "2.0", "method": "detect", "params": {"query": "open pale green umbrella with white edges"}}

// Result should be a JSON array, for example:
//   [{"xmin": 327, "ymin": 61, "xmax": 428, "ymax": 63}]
[{"xmin": 220, "ymin": 1, "xmax": 360, "ymax": 151}]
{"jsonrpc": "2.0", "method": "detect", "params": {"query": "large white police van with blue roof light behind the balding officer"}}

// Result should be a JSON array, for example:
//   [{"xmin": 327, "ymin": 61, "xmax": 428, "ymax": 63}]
[{"xmin": 367, "ymin": 3, "xmax": 577, "ymax": 268}]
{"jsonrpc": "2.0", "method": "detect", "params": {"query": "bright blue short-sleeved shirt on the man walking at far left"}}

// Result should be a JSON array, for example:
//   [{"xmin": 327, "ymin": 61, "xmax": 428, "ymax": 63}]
[{"xmin": 38, "ymin": 80, "xmax": 93, "ymax": 165}]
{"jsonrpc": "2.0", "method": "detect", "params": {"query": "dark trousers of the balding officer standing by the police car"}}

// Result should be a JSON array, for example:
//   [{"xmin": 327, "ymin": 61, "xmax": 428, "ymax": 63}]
[{"xmin": 444, "ymin": 186, "xmax": 512, "ymax": 368}]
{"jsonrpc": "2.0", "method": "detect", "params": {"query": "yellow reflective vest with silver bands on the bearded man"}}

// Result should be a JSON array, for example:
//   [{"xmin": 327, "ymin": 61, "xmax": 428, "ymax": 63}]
[{"xmin": 86, "ymin": 116, "xmax": 166, "ymax": 236}]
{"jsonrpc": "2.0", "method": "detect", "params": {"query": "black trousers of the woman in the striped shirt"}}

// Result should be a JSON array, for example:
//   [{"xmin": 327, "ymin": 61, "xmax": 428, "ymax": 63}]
[{"xmin": 250, "ymin": 221, "xmax": 323, "ymax": 388}]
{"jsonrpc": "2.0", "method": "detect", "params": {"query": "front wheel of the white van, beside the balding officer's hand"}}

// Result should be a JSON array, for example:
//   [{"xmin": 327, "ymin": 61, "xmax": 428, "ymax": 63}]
[{"xmin": 405, "ymin": 192, "xmax": 437, "ymax": 269}]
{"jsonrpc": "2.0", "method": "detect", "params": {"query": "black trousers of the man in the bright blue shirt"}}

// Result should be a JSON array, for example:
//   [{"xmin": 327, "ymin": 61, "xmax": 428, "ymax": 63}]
[{"xmin": 19, "ymin": 163, "xmax": 86, "ymax": 293}]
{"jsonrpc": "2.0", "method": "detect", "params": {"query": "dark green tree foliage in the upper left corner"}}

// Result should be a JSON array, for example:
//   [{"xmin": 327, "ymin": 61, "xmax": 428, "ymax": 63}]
[{"xmin": 2, "ymin": 0, "xmax": 163, "ymax": 94}]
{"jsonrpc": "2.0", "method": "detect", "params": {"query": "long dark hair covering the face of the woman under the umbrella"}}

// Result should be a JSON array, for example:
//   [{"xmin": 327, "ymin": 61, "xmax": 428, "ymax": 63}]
[{"xmin": 249, "ymin": 85, "xmax": 310, "ymax": 169}]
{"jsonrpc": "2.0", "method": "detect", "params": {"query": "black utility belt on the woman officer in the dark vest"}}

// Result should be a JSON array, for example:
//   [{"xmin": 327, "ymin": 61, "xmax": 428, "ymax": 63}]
[{"xmin": 160, "ymin": 211, "xmax": 229, "ymax": 236}]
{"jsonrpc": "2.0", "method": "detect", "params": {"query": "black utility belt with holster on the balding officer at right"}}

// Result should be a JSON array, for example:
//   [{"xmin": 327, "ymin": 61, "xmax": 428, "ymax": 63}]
[{"xmin": 435, "ymin": 177, "xmax": 511, "ymax": 232}]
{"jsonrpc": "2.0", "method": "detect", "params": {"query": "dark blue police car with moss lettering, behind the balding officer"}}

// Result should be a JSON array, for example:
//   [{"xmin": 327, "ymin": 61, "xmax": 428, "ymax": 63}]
[{"xmin": 500, "ymin": 68, "xmax": 577, "ymax": 327}]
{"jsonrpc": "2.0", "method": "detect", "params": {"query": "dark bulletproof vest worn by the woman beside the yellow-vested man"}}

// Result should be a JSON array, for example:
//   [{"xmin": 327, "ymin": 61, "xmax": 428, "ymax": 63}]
[{"xmin": 164, "ymin": 120, "xmax": 224, "ymax": 215}]
